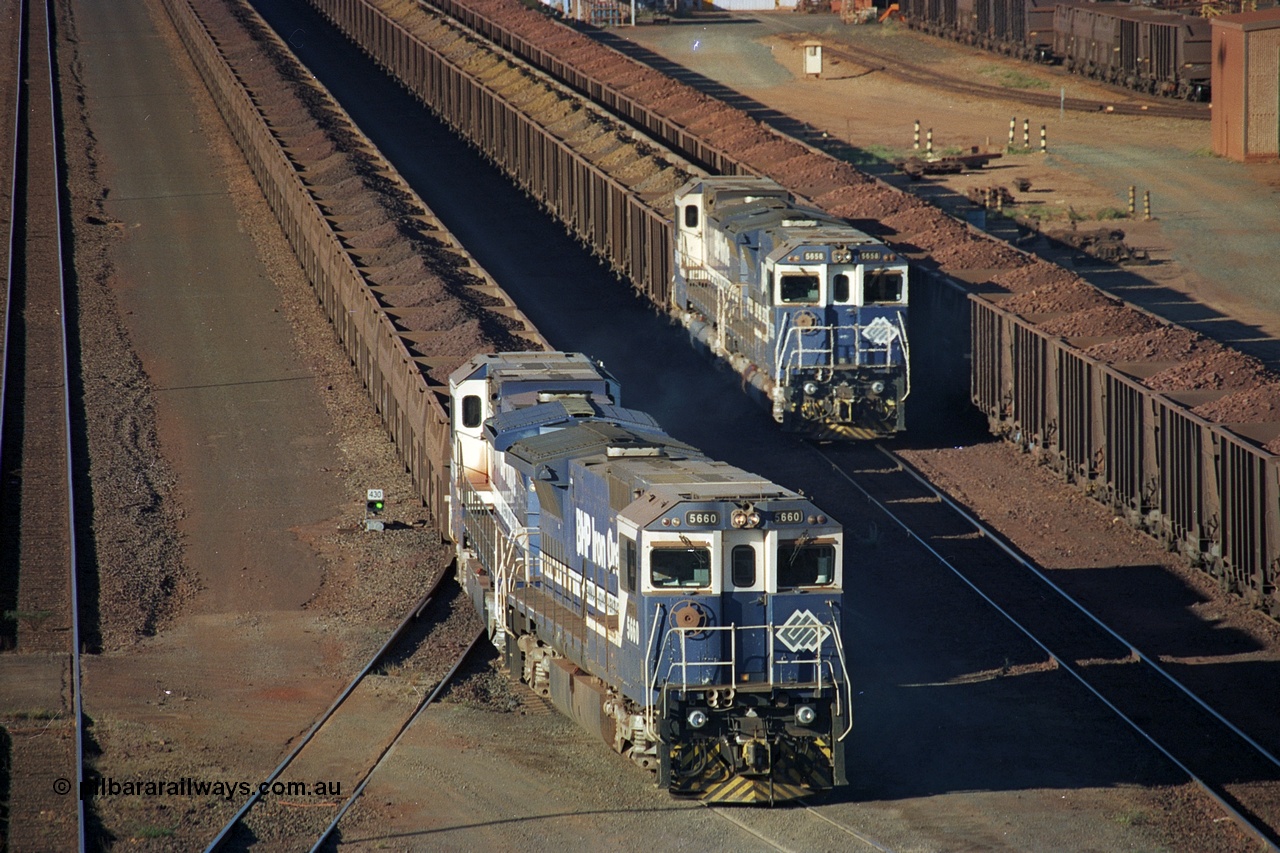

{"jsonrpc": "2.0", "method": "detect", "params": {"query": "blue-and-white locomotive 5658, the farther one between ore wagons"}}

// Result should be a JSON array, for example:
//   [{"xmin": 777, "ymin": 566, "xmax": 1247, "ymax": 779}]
[{"xmin": 672, "ymin": 177, "xmax": 911, "ymax": 439}]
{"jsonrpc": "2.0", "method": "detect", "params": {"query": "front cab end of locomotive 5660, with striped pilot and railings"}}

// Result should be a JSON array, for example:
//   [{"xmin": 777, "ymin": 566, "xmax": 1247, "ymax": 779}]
[{"xmin": 618, "ymin": 487, "xmax": 851, "ymax": 802}]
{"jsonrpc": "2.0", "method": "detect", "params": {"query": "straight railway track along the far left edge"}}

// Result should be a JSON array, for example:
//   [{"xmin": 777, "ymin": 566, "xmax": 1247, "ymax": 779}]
[{"xmin": 0, "ymin": 0, "xmax": 86, "ymax": 849}]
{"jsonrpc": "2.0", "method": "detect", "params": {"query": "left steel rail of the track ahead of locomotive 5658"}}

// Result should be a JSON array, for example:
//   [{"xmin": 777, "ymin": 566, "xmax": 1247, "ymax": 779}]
[{"xmin": 809, "ymin": 444, "xmax": 1280, "ymax": 853}]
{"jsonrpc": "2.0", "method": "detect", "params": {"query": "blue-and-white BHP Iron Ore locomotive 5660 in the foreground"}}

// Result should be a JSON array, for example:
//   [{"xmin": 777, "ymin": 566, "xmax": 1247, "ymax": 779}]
[{"xmin": 449, "ymin": 352, "xmax": 852, "ymax": 803}]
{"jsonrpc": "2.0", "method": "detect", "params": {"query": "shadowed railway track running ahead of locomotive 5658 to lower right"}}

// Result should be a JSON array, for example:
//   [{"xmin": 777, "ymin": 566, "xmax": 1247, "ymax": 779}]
[{"xmin": 814, "ymin": 447, "xmax": 1280, "ymax": 849}]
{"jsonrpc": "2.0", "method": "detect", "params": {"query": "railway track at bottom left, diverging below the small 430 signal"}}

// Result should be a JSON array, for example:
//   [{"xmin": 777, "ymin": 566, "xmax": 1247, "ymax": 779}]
[{"xmin": 206, "ymin": 563, "xmax": 484, "ymax": 853}]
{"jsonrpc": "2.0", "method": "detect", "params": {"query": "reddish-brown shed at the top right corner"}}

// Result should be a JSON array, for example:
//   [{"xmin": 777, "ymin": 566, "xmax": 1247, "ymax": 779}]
[{"xmin": 1212, "ymin": 8, "xmax": 1280, "ymax": 161}]
